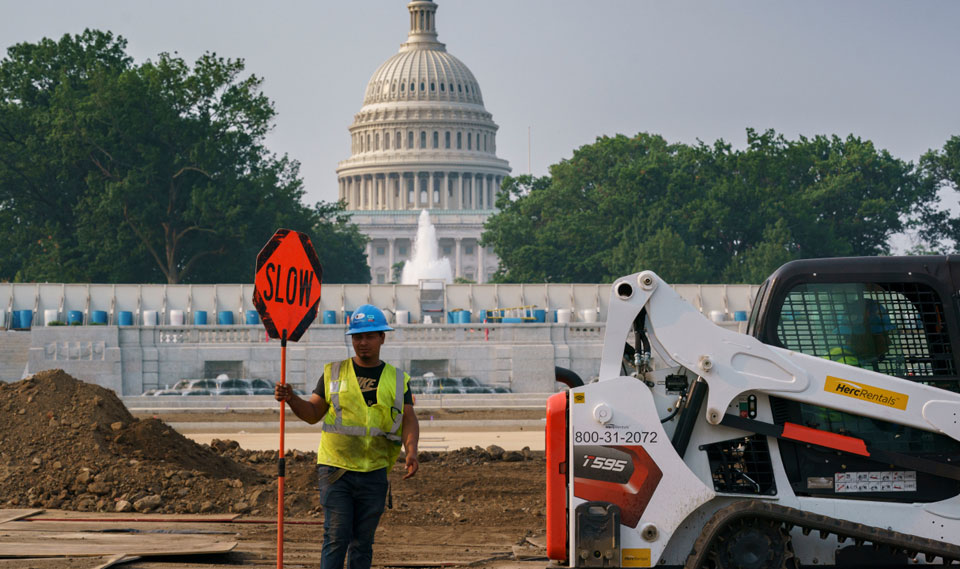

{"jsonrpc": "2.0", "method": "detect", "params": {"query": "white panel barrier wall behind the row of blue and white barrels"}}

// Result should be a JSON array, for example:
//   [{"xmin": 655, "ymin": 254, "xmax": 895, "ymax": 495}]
[{"xmin": 0, "ymin": 283, "xmax": 758, "ymax": 329}]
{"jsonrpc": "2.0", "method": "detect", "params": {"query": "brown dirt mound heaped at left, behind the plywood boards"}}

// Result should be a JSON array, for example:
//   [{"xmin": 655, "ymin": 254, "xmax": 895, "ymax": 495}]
[{"xmin": 0, "ymin": 370, "xmax": 267, "ymax": 512}]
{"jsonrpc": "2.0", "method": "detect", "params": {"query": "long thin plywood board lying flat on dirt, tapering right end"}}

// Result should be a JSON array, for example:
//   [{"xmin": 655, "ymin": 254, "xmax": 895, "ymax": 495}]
[{"xmin": 0, "ymin": 530, "xmax": 237, "ymax": 558}]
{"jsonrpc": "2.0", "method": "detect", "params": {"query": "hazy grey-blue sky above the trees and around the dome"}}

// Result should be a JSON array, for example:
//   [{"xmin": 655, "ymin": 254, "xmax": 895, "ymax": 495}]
[{"xmin": 0, "ymin": 0, "xmax": 960, "ymax": 213}]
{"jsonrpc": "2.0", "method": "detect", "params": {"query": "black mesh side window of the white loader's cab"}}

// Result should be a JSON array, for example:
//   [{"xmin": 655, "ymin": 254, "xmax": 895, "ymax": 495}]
[{"xmin": 777, "ymin": 283, "xmax": 960, "ymax": 391}]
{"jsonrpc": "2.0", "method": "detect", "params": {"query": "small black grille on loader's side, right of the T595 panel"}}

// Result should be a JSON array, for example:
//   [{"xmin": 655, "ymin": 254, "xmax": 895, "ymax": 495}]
[{"xmin": 700, "ymin": 435, "xmax": 777, "ymax": 495}]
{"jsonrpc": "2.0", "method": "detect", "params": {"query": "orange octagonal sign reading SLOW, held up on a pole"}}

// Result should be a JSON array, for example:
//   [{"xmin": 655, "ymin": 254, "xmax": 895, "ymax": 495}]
[{"xmin": 253, "ymin": 229, "xmax": 323, "ymax": 342}]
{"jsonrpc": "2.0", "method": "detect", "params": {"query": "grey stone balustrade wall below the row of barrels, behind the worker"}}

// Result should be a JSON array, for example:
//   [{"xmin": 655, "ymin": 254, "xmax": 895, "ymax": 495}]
[{"xmin": 15, "ymin": 322, "xmax": 745, "ymax": 396}]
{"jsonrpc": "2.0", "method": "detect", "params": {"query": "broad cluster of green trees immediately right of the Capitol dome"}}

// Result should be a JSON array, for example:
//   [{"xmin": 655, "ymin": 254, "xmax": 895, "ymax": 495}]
[{"xmin": 483, "ymin": 129, "xmax": 937, "ymax": 282}]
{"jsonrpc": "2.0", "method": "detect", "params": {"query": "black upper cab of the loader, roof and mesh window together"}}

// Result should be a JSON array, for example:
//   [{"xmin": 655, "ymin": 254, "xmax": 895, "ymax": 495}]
[{"xmin": 748, "ymin": 256, "xmax": 960, "ymax": 392}]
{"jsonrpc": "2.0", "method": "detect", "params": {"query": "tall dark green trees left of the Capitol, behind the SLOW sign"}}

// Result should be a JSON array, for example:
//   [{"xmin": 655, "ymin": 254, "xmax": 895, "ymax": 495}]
[{"xmin": 0, "ymin": 30, "xmax": 369, "ymax": 283}]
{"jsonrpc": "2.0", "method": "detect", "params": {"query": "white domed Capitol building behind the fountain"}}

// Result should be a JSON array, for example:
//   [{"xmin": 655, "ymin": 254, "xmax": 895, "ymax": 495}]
[{"xmin": 337, "ymin": 0, "xmax": 510, "ymax": 284}]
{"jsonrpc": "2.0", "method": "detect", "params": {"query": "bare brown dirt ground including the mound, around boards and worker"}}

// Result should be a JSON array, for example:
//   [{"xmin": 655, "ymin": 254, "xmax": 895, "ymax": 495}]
[{"xmin": 0, "ymin": 370, "xmax": 545, "ymax": 569}]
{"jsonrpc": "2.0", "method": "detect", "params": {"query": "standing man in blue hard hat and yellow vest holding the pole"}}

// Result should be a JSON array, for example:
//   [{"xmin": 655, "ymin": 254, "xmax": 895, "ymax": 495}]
[{"xmin": 274, "ymin": 304, "xmax": 420, "ymax": 569}]
